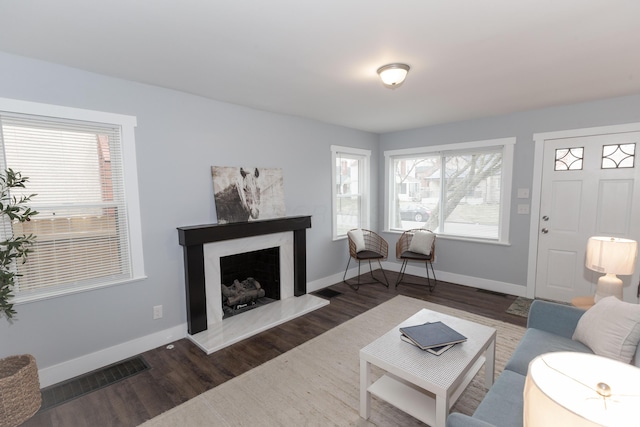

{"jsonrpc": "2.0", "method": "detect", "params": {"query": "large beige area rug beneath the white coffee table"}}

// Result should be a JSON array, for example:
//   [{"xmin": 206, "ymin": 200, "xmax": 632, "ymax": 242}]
[{"xmin": 143, "ymin": 296, "xmax": 524, "ymax": 427}]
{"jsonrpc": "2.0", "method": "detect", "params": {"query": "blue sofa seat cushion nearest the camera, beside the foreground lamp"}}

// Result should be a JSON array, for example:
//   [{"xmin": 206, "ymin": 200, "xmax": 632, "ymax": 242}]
[{"xmin": 473, "ymin": 370, "xmax": 526, "ymax": 427}]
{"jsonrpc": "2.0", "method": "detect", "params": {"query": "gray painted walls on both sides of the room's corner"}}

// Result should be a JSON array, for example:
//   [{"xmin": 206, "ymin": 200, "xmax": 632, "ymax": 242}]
[{"xmin": 0, "ymin": 49, "xmax": 640, "ymax": 378}]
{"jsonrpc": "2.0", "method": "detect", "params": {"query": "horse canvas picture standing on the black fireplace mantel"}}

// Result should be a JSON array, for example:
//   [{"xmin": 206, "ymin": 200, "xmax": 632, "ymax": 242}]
[{"xmin": 211, "ymin": 166, "xmax": 286, "ymax": 224}]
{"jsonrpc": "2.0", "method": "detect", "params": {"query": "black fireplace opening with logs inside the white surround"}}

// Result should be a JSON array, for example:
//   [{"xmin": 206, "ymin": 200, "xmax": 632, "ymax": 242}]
[{"xmin": 220, "ymin": 247, "xmax": 280, "ymax": 319}]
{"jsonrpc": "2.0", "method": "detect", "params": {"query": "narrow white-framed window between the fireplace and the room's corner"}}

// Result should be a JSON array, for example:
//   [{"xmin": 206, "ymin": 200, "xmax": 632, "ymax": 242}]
[{"xmin": 331, "ymin": 145, "xmax": 371, "ymax": 240}]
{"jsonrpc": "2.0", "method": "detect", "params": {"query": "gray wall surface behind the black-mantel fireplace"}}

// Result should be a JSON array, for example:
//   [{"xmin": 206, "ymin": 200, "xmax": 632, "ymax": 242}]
[{"xmin": 0, "ymin": 53, "xmax": 379, "ymax": 368}]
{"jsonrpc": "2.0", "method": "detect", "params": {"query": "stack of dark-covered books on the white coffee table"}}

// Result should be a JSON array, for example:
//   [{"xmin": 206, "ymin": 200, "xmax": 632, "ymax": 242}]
[{"xmin": 400, "ymin": 322, "xmax": 467, "ymax": 356}]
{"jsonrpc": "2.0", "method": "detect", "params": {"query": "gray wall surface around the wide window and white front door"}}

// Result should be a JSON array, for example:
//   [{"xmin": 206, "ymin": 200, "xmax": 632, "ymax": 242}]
[{"xmin": 379, "ymin": 95, "xmax": 640, "ymax": 295}]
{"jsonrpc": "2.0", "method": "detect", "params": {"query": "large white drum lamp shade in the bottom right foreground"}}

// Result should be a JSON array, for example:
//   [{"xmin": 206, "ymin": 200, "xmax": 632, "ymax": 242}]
[{"xmin": 523, "ymin": 352, "xmax": 640, "ymax": 427}]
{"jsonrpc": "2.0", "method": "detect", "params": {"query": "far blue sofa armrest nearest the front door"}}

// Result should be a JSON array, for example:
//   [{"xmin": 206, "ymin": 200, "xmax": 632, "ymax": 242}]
[{"xmin": 527, "ymin": 300, "xmax": 585, "ymax": 339}]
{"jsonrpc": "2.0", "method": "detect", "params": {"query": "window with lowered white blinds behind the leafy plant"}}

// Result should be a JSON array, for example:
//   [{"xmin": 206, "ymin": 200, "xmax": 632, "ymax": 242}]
[{"xmin": 0, "ymin": 99, "xmax": 144, "ymax": 302}]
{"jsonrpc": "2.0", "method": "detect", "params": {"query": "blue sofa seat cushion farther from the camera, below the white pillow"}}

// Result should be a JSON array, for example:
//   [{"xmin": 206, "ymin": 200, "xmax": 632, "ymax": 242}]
[{"xmin": 505, "ymin": 328, "xmax": 593, "ymax": 375}]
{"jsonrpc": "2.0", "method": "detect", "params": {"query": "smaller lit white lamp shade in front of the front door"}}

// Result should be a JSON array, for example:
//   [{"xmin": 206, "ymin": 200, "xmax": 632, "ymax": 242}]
[{"xmin": 585, "ymin": 236, "xmax": 638, "ymax": 275}]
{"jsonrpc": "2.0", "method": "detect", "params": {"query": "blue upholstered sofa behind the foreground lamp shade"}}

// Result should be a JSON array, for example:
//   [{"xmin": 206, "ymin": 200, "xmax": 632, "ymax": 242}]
[{"xmin": 447, "ymin": 300, "xmax": 640, "ymax": 427}]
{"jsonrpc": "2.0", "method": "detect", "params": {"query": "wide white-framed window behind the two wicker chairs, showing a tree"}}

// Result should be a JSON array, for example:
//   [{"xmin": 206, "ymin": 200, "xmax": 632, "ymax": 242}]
[{"xmin": 385, "ymin": 138, "xmax": 515, "ymax": 243}]
